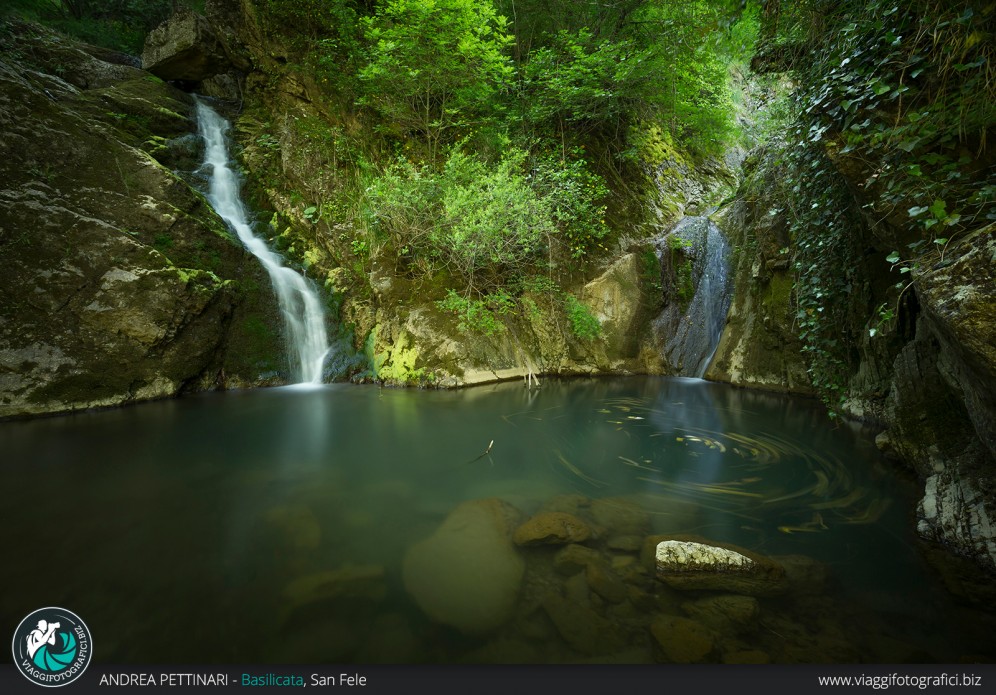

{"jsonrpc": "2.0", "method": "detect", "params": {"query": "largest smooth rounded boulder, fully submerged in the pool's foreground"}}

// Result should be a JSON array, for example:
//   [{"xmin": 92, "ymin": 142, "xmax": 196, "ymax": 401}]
[{"xmin": 402, "ymin": 499, "xmax": 525, "ymax": 634}]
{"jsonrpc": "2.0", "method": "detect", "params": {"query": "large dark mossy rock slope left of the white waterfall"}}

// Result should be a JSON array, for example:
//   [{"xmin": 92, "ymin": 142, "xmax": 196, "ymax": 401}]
[{"xmin": 0, "ymin": 23, "xmax": 280, "ymax": 417}]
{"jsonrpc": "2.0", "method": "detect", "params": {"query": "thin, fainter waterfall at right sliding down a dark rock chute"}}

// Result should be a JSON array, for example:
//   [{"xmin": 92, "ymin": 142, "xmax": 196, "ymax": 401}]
[{"xmin": 653, "ymin": 216, "xmax": 732, "ymax": 378}]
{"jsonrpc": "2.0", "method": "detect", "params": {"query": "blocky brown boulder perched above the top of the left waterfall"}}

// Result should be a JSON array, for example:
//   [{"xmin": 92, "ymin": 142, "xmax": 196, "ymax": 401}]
[{"xmin": 142, "ymin": 12, "xmax": 231, "ymax": 82}]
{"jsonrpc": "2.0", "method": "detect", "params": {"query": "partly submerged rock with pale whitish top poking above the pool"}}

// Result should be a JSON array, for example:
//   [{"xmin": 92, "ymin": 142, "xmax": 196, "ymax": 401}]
[{"xmin": 657, "ymin": 539, "xmax": 788, "ymax": 596}]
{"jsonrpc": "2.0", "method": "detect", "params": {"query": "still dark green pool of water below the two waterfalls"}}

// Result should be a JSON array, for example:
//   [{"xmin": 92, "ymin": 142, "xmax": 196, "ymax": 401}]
[{"xmin": 0, "ymin": 378, "xmax": 996, "ymax": 663}]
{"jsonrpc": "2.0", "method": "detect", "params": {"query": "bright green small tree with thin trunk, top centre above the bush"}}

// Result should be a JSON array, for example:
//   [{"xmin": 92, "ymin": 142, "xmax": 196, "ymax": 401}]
[{"xmin": 359, "ymin": 0, "xmax": 512, "ymax": 160}]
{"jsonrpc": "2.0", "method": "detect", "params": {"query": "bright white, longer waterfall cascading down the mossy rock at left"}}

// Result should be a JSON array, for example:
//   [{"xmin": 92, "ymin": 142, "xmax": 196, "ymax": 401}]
[{"xmin": 197, "ymin": 99, "xmax": 329, "ymax": 384}]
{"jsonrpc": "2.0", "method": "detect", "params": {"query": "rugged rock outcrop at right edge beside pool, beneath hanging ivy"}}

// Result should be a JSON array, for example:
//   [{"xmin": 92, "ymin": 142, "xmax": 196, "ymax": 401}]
[{"xmin": 886, "ymin": 225, "xmax": 996, "ymax": 571}]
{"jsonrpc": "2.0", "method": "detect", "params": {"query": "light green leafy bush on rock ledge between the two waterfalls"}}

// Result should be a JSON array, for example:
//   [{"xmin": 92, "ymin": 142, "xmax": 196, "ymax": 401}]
[{"xmin": 364, "ymin": 144, "xmax": 608, "ymax": 292}]
